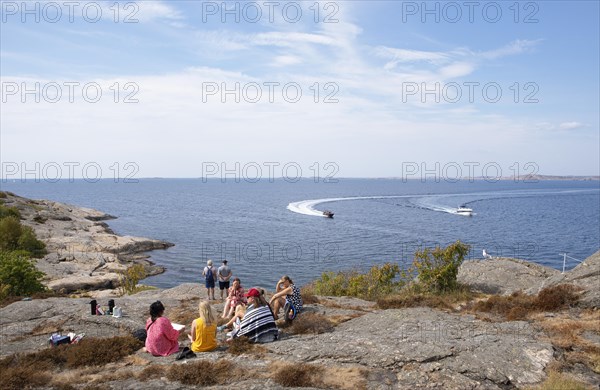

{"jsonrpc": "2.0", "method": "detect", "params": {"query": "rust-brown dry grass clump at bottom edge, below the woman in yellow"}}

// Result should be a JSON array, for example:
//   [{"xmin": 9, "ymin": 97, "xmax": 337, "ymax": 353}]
[{"xmin": 167, "ymin": 360, "xmax": 246, "ymax": 386}]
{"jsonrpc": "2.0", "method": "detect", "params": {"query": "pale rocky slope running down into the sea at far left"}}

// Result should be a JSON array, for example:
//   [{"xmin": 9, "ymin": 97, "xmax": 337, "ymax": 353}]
[{"xmin": 2, "ymin": 193, "xmax": 174, "ymax": 293}]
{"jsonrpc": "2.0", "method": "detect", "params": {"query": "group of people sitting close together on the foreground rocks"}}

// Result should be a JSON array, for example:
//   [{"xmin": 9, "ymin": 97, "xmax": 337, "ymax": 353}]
[{"xmin": 145, "ymin": 275, "xmax": 303, "ymax": 356}]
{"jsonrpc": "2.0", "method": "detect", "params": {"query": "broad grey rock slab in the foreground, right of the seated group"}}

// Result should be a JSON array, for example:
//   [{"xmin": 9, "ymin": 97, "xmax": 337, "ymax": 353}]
[{"xmin": 266, "ymin": 308, "xmax": 553, "ymax": 388}]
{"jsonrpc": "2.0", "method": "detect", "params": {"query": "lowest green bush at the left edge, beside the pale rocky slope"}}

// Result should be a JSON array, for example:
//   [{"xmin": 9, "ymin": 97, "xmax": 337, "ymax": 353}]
[{"xmin": 0, "ymin": 251, "xmax": 45, "ymax": 296}]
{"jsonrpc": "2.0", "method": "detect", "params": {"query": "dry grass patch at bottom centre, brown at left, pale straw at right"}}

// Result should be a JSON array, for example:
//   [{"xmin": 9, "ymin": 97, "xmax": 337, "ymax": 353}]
[{"xmin": 270, "ymin": 362, "xmax": 368, "ymax": 390}]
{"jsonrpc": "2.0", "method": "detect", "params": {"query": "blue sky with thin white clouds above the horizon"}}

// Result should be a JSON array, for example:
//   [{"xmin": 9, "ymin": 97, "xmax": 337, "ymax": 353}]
[{"xmin": 0, "ymin": 1, "xmax": 600, "ymax": 181}]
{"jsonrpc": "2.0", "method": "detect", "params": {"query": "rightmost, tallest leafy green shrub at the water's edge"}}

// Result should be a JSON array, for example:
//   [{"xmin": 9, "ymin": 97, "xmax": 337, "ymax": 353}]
[{"xmin": 413, "ymin": 241, "xmax": 469, "ymax": 292}]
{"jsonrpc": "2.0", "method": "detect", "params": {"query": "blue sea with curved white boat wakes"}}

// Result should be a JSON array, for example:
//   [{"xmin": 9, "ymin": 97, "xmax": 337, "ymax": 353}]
[{"xmin": 1, "ymin": 179, "xmax": 600, "ymax": 288}]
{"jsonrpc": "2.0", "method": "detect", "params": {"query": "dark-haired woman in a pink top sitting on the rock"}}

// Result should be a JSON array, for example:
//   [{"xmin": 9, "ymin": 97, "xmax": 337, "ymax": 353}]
[{"xmin": 146, "ymin": 301, "xmax": 179, "ymax": 356}]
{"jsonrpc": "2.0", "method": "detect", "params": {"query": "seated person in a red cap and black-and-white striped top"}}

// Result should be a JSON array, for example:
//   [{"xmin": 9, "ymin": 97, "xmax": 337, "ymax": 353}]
[{"xmin": 231, "ymin": 288, "xmax": 279, "ymax": 343}]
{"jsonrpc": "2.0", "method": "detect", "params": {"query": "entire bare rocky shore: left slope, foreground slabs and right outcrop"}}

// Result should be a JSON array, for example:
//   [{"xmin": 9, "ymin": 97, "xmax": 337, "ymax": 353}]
[{"xmin": 0, "ymin": 194, "xmax": 600, "ymax": 390}]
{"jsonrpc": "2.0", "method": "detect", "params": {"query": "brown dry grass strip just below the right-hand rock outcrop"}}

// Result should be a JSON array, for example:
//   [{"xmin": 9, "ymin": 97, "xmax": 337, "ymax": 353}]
[{"xmin": 472, "ymin": 284, "xmax": 579, "ymax": 321}]
